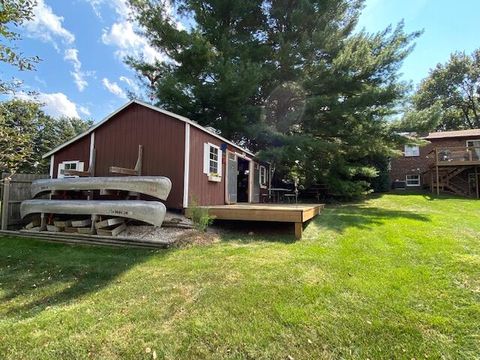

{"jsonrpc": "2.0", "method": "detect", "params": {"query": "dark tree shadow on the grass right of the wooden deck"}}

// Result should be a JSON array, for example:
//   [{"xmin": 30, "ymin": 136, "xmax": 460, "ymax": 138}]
[{"xmin": 313, "ymin": 204, "xmax": 430, "ymax": 232}]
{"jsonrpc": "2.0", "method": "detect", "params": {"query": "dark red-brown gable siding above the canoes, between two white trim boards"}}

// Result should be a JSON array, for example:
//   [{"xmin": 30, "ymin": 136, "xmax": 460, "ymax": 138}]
[{"xmin": 95, "ymin": 104, "xmax": 185, "ymax": 209}]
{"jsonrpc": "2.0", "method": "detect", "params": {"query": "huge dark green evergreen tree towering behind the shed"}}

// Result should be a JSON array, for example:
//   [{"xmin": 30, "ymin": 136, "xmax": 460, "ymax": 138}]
[{"xmin": 127, "ymin": 0, "xmax": 419, "ymax": 196}]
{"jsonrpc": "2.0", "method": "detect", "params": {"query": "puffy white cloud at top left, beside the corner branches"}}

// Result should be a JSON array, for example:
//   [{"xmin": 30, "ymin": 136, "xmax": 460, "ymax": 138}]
[{"xmin": 25, "ymin": 0, "xmax": 75, "ymax": 48}]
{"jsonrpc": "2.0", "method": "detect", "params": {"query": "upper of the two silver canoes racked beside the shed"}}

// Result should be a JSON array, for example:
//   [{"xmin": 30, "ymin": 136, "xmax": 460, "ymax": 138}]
[{"xmin": 31, "ymin": 176, "xmax": 172, "ymax": 200}]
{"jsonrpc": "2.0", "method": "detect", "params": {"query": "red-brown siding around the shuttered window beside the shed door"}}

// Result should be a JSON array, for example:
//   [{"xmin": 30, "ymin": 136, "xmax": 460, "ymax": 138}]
[{"xmin": 188, "ymin": 126, "xmax": 225, "ymax": 205}]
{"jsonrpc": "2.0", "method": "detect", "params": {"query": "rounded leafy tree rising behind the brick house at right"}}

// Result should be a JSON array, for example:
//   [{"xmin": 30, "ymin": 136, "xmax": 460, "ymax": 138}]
[{"xmin": 405, "ymin": 49, "xmax": 480, "ymax": 130}]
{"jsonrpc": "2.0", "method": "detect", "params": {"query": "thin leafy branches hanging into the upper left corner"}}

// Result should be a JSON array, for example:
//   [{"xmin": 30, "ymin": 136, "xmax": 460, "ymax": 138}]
[{"xmin": 0, "ymin": 0, "xmax": 40, "ymax": 94}]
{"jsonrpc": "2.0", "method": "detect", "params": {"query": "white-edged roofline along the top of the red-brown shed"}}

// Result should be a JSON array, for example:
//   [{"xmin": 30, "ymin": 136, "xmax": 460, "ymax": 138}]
[{"xmin": 42, "ymin": 99, "xmax": 255, "ymax": 159}]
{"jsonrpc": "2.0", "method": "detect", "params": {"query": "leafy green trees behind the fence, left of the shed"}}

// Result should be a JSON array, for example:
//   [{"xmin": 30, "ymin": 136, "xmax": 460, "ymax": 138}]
[{"xmin": 0, "ymin": 99, "xmax": 92, "ymax": 174}]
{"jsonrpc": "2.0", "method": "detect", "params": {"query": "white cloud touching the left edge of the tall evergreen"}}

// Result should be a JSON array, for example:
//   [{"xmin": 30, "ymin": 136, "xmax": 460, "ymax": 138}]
[{"xmin": 102, "ymin": 21, "xmax": 165, "ymax": 63}]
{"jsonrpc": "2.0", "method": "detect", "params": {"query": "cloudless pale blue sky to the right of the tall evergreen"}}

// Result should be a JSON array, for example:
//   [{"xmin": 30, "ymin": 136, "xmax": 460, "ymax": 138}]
[{"xmin": 358, "ymin": 0, "xmax": 480, "ymax": 85}]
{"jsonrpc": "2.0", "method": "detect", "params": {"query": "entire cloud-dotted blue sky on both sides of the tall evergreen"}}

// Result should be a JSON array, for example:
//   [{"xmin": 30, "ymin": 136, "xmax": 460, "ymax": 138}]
[{"xmin": 0, "ymin": 0, "xmax": 480, "ymax": 121}]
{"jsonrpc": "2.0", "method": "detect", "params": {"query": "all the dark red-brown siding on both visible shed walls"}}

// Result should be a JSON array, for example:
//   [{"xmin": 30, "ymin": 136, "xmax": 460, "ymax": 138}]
[{"xmin": 50, "ymin": 104, "xmax": 265, "ymax": 209}]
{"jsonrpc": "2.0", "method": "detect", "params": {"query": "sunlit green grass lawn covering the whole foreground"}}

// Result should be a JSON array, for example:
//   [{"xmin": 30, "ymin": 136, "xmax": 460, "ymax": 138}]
[{"xmin": 0, "ymin": 195, "xmax": 480, "ymax": 359}]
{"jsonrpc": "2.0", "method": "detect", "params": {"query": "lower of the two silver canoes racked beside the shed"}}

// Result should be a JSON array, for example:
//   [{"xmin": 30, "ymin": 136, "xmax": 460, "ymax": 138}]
[{"xmin": 20, "ymin": 199, "xmax": 167, "ymax": 226}]
